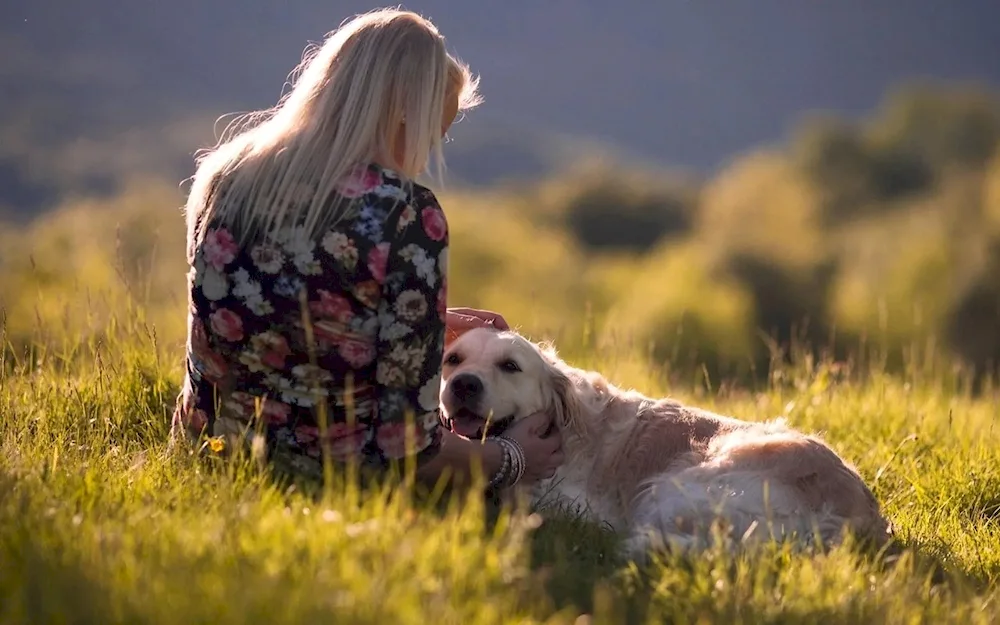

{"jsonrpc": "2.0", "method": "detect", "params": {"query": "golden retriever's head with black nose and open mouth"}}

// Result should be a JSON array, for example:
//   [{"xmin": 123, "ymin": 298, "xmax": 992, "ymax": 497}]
[{"xmin": 441, "ymin": 328, "xmax": 595, "ymax": 438}]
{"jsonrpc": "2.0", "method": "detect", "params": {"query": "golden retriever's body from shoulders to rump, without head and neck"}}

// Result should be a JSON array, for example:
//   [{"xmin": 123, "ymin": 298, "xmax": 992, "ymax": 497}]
[{"xmin": 544, "ymin": 387, "xmax": 888, "ymax": 555}]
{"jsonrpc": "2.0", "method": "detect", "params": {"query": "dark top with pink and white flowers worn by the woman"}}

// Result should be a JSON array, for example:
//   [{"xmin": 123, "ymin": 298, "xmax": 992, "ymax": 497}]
[{"xmin": 174, "ymin": 165, "xmax": 448, "ymax": 474}]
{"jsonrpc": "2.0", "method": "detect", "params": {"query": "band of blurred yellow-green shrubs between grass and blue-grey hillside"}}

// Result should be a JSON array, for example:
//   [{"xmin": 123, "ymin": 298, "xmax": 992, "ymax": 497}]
[{"xmin": 0, "ymin": 81, "xmax": 1000, "ymax": 379}]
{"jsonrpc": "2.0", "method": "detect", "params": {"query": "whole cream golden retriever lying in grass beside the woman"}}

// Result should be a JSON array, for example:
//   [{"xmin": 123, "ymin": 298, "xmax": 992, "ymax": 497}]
[{"xmin": 441, "ymin": 328, "xmax": 891, "ymax": 558}]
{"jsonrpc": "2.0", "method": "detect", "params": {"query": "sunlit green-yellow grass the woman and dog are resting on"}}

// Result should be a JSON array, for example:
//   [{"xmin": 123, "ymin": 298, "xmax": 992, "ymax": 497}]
[{"xmin": 0, "ymin": 308, "xmax": 1000, "ymax": 624}]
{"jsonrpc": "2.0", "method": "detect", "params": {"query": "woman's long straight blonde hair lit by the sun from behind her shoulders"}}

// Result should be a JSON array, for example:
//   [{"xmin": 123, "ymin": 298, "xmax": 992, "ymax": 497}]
[{"xmin": 185, "ymin": 9, "xmax": 481, "ymax": 259}]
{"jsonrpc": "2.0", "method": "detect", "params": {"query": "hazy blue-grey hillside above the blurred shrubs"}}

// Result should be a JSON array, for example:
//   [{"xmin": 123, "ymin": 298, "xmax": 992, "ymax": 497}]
[{"xmin": 0, "ymin": 0, "xmax": 1000, "ymax": 211}]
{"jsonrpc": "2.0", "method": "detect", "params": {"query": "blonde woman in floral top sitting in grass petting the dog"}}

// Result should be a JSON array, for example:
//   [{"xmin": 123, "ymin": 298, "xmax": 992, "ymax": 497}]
[{"xmin": 174, "ymin": 10, "xmax": 562, "ymax": 486}]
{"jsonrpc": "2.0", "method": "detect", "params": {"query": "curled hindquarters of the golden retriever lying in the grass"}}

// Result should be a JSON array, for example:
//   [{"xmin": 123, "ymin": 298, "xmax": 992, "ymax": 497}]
[{"xmin": 631, "ymin": 411, "xmax": 889, "ymax": 549}]
